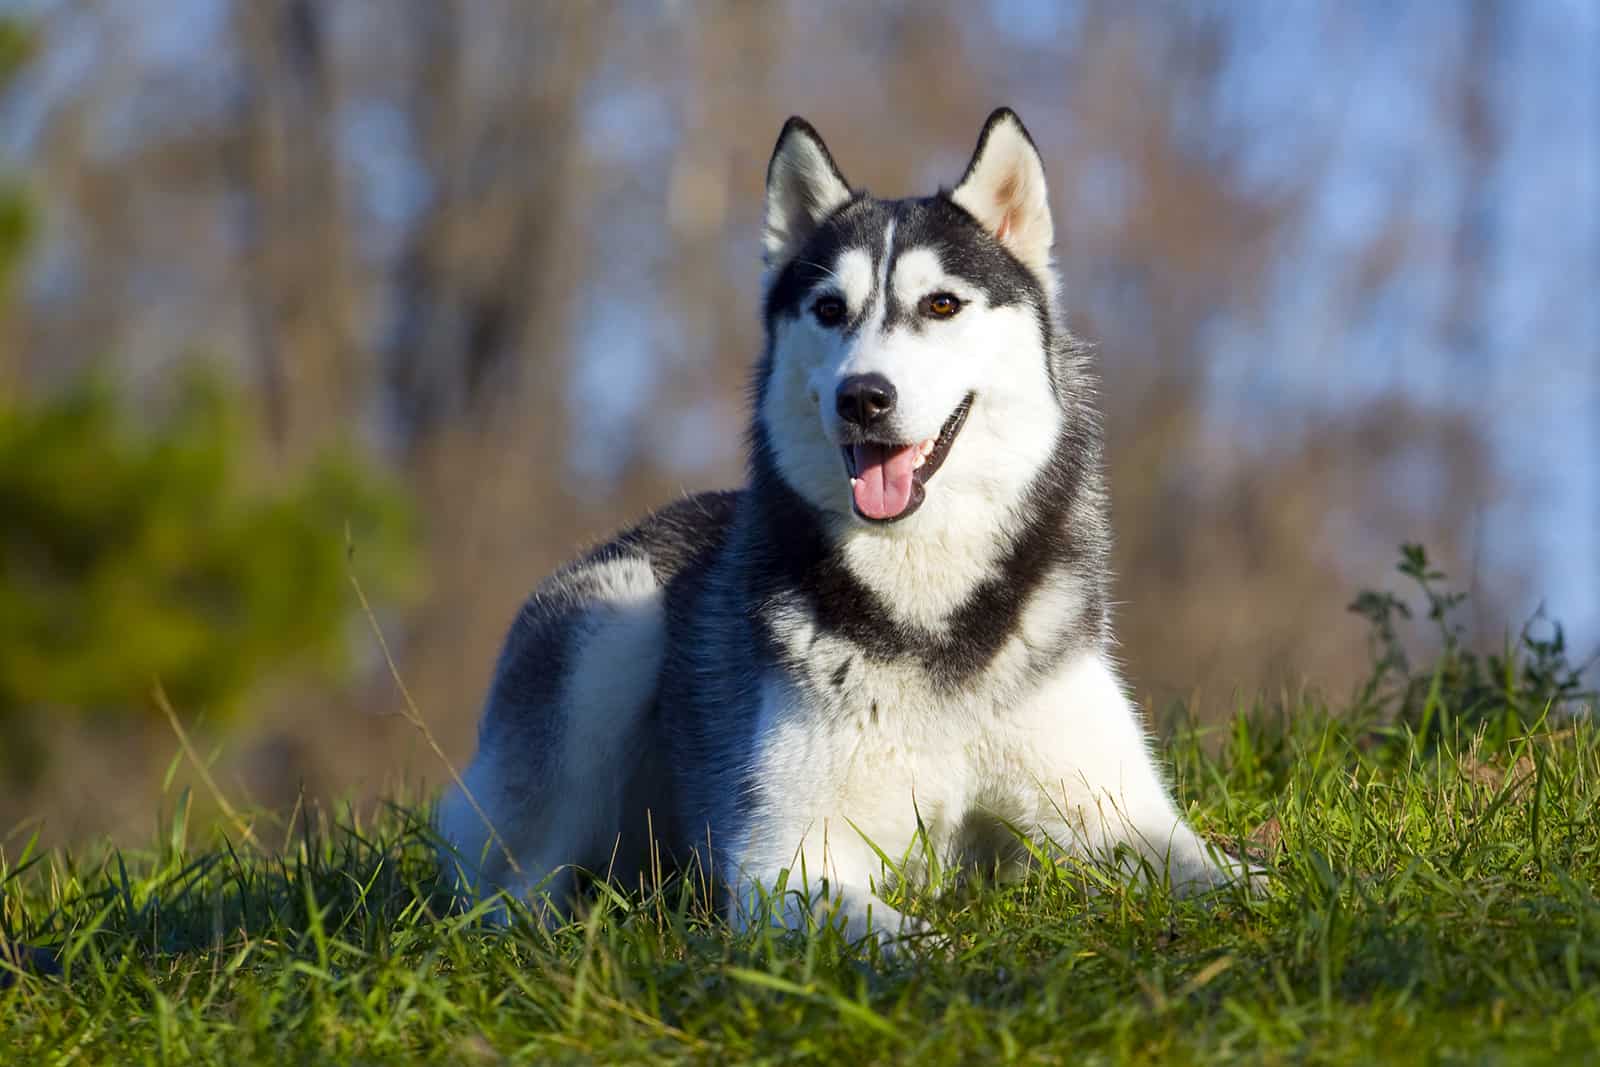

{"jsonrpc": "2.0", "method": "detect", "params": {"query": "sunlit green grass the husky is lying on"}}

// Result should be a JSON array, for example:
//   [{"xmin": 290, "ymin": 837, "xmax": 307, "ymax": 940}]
[{"xmin": 0, "ymin": 705, "xmax": 1600, "ymax": 1065}]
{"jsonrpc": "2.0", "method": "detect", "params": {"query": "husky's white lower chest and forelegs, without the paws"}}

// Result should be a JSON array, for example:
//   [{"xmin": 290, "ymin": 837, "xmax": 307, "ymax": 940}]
[{"xmin": 739, "ymin": 654, "xmax": 1192, "ymax": 885}]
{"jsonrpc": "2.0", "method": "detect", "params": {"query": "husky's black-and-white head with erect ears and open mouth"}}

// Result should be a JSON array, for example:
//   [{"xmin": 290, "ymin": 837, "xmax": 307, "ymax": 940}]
[{"xmin": 757, "ymin": 109, "xmax": 1064, "ymax": 534}]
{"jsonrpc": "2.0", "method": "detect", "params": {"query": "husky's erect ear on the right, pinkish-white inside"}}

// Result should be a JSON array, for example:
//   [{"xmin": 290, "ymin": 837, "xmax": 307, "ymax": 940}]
[{"xmin": 950, "ymin": 107, "xmax": 1056, "ymax": 274}]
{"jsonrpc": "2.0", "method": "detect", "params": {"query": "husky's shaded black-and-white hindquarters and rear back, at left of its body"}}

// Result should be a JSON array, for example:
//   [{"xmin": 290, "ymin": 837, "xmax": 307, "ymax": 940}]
[{"xmin": 438, "ymin": 493, "xmax": 739, "ymax": 901}]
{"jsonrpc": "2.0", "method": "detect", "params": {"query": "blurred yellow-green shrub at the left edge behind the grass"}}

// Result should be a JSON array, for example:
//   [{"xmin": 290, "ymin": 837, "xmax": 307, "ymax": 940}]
[{"xmin": 0, "ymin": 373, "xmax": 416, "ymax": 769}]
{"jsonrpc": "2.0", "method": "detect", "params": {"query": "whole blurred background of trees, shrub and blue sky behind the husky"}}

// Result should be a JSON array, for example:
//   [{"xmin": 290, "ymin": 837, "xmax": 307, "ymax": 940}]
[{"xmin": 0, "ymin": 0, "xmax": 1600, "ymax": 848}]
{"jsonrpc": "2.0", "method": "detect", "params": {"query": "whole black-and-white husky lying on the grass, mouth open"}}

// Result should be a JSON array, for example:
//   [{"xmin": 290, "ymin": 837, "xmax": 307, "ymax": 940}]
[{"xmin": 440, "ymin": 109, "xmax": 1250, "ymax": 941}]
